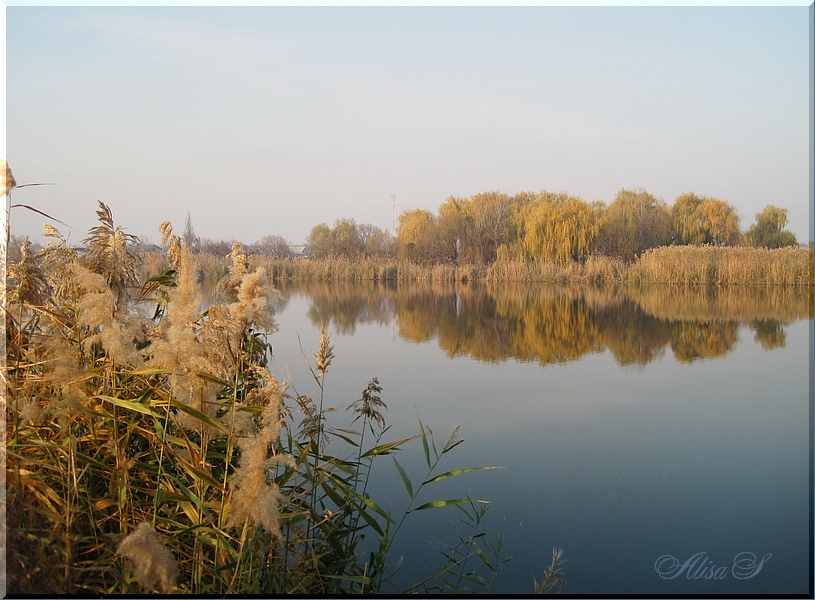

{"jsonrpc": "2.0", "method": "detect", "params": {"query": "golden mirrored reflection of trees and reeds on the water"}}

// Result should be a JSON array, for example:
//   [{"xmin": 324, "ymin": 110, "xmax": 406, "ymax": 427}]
[{"xmin": 282, "ymin": 282, "xmax": 813, "ymax": 365}]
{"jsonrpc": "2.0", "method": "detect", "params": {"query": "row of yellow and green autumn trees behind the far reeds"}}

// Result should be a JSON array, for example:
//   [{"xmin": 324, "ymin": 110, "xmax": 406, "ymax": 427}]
[{"xmin": 396, "ymin": 189, "xmax": 798, "ymax": 264}]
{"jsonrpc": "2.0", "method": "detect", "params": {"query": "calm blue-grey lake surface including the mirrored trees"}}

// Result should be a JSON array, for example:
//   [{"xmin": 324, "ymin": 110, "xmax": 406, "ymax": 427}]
[{"xmin": 262, "ymin": 284, "xmax": 813, "ymax": 594}]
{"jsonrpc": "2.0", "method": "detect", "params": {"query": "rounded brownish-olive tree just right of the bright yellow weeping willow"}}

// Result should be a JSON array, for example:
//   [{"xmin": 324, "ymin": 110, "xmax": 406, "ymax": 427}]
[{"xmin": 597, "ymin": 189, "xmax": 673, "ymax": 260}]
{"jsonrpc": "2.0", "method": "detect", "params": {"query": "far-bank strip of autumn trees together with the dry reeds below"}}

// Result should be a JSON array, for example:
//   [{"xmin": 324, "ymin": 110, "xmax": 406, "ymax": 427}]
[{"xmin": 137, "ymin": 189, "xmax": 813, "ymax": 286}]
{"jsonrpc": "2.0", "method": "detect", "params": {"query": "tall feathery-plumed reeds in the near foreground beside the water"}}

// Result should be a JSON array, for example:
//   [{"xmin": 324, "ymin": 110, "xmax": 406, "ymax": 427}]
[{"xmin": 4, "ymin": 203, "xmax": 565, "ymax": 596}]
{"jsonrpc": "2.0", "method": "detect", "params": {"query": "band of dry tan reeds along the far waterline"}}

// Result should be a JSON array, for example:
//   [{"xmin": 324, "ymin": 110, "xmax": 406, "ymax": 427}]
[{"xmin": 137, "ymin": 246, "xmax": 813, "ymax": 287}]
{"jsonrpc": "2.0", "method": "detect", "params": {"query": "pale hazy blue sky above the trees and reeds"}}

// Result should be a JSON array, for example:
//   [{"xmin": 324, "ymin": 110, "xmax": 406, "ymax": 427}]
[{"xmin": 5, "ymin": 5, "xmax": 812, "ymax": 243}]
